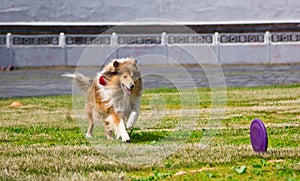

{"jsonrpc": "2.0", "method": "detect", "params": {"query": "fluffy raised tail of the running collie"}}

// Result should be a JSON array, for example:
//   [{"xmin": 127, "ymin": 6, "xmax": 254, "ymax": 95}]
[{"xmin": 62, "ymin": 73, "xmax": 92, "ymax": 93}]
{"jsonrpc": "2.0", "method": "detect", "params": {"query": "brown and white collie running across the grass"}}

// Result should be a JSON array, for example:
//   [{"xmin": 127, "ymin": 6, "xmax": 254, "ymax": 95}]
[{"xmin": 63, "ymin": 58, "xmax": 142, "ymax": 142}]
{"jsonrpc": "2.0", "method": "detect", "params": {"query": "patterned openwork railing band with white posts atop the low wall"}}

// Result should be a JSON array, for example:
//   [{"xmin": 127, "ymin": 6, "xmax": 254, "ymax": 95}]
[{"xmin": 0, "ymin": 32, "xmax": 300, "ymax": 47}]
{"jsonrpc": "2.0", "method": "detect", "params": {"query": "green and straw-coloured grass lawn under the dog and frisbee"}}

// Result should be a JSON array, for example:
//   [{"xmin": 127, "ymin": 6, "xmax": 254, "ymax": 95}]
[{"xmin": 0, "ymin": 85, "xmax": 300, "ymax": 180}]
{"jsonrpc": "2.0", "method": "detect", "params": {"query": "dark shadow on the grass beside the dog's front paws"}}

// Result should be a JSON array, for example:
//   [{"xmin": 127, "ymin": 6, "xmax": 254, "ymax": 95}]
[{"xmin": 130, "ymin": 130, "xmax": 169, "ymax": 143}]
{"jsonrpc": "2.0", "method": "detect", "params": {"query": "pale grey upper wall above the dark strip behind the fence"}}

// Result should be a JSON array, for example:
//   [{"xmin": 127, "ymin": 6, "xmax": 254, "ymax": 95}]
[{"xmin": 0, "ymin": 0, "xmax": 300, "ymax": 22}]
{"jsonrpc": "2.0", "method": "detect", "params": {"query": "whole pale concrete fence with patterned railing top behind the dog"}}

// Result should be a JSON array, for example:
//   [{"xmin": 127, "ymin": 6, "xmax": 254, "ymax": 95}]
[{"xmin": 0, "ymin": 32, "xmax": 300, "ymax": 67}]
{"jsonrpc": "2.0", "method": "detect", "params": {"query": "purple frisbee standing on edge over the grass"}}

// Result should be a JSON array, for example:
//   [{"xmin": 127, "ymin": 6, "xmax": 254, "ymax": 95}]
[{"xmin": 250, "ymin": 119, "xmax": 268, "ymax": 152}]
